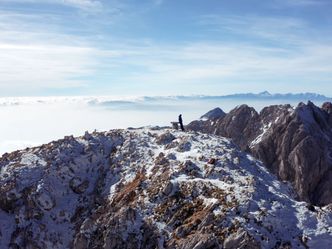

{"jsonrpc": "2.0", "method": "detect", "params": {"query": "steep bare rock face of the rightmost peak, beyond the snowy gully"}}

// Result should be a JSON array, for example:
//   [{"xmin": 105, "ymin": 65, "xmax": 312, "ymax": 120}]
[{"xmin": 251, "ymin": 102, "xmax": 332, "ymax": 205}]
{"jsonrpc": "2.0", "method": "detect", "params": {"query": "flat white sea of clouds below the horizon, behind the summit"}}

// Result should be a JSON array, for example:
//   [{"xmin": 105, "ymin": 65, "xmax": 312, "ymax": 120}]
[{"xmin": 0, "ymin": 96, "xmax": 321, "ymax": 155}]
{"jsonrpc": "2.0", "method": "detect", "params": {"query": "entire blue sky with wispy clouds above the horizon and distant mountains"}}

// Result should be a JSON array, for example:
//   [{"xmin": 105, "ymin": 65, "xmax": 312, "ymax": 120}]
[{"xmin": 0, "ymin": 0, "xmax": 332, "ymax": 96}]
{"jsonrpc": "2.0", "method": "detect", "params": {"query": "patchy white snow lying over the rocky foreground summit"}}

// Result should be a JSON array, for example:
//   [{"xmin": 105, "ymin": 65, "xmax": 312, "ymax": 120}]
[{"xmin": 0, "ymin": 127, "xmax": 332, "ymax": 249}]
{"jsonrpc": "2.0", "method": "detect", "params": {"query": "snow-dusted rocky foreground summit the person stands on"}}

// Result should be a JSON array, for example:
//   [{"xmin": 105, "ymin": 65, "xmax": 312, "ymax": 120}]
[{"xmin": 0, "ymin": 128, "xmax": 332, "ymax": 249}]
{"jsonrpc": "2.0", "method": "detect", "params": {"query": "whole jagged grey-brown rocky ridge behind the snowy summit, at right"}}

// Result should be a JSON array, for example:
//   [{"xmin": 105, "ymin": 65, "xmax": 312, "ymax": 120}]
[{"xmin": 187, "ymin": 102, "xmax": 332, "ymax": 205}]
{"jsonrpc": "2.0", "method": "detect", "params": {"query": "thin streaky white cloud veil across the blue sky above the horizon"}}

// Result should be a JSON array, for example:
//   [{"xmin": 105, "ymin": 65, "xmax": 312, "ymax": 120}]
[{"xmin": 0, "ymin": 0, "xmax": 332, "ymax": 95}]
